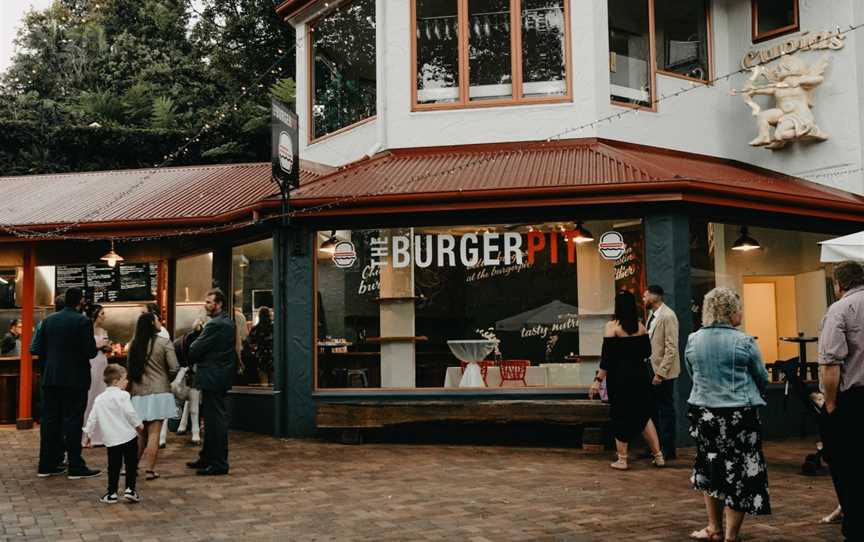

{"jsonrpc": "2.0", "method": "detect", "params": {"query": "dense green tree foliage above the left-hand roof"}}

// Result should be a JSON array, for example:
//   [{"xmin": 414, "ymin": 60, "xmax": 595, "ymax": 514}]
[{"xmin": 0, "ymin": 0, "xmax": 295, "ymax": 174}]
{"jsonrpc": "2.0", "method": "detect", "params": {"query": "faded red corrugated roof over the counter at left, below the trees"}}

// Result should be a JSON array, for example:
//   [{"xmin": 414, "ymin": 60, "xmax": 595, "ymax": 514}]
[{"xmin": 0, "ymin": 161, "xmax": 333, "ymax": 233}]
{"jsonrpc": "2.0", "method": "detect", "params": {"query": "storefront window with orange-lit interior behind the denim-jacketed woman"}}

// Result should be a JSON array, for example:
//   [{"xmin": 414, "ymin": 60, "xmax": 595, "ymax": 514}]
[{"xmin": 691, "ymin": 222, "xmax": 833, "ymax": 380}]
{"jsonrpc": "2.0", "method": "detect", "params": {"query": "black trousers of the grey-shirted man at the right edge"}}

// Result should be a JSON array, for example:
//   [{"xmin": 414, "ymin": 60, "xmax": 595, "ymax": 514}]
[{"xmin": 823, "ymin": 387, "xmax": 864, "ymax": 542}]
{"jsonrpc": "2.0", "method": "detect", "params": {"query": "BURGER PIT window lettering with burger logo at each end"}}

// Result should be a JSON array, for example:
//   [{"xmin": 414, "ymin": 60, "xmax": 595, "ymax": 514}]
[{"xmin": 333, "ymin": 231, "xmax": 626, "ymax": 269}]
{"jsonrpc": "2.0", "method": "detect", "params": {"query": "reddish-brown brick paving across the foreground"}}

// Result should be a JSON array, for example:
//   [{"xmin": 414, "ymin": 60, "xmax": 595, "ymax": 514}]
[{"xmin": 0, "ymin": 429, "xmax": 840, "ymax": 542}]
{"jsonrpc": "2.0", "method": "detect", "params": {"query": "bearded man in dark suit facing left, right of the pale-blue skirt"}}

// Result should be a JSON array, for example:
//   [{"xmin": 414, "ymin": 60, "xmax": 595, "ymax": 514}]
[{"xmin": 186, "ymin": 288, "xmax": 237, "ymax": 475}]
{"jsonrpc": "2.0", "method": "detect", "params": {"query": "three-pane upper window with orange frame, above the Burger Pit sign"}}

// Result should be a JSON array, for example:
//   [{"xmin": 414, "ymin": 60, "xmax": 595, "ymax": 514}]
[{"xmin": 412, "ymin": 0, "xmax": 570, "ymax": 109}]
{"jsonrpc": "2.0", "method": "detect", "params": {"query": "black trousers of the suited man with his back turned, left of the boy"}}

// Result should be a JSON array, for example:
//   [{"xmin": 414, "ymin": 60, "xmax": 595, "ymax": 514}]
[{"xmin": 39, "ymin": 387, "xmax": 87, "ymax": 472}]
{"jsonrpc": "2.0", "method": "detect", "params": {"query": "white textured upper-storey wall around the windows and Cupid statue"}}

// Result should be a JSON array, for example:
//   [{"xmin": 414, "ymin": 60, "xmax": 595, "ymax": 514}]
[{"xmin": 297, "ymin": 0, "xmax": 864, "ymax": 193}]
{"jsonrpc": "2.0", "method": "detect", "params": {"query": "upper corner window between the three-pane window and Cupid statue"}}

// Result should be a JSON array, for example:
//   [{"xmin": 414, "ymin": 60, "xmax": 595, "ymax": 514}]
[{"xmin": 608, "ymin": 0, "xmax": 711, "ymax": 109}]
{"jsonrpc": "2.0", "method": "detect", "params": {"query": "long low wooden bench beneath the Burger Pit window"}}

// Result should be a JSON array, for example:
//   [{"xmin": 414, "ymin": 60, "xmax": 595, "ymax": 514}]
[{"xmin": 316, "ymin": 399, "xmax": 609, "ymax": 451}]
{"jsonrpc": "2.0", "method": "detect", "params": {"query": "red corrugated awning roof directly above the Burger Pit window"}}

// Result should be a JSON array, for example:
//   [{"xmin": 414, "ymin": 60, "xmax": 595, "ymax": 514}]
[{"xmin": 291, "ymin": 139, "xmax": 864, "ymax": 222}]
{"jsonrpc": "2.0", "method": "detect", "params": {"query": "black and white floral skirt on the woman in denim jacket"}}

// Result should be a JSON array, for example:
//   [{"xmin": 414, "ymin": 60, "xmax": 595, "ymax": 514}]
[{"xmin": 689, "ymin": 405, "xmax": 771, "ymax": 515}]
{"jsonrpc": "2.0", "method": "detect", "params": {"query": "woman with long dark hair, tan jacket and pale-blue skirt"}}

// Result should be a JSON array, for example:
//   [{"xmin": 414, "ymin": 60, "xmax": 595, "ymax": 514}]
[{"xmin": 128, "ymin": 312, "xmax": 177, "ymax": 480}]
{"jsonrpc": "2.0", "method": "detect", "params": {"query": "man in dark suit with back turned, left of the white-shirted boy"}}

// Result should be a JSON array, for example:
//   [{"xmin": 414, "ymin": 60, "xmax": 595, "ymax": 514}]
[{"xmin": 30, "ymin": 288, "xmax": 99, "ymax": 480}]
